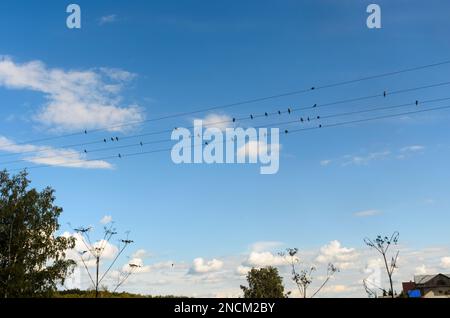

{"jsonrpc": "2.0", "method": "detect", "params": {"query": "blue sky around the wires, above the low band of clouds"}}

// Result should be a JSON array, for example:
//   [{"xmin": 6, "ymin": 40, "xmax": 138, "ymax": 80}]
[{"xmin": 0, "ymin": 1, "xmax": 450, "ymax": 294}]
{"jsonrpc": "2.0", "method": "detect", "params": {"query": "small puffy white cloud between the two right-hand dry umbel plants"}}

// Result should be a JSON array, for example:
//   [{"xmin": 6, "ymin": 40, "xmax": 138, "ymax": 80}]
[{"xmin": 316, "ymin": 240, "xmax": 358, "ymax": 269}]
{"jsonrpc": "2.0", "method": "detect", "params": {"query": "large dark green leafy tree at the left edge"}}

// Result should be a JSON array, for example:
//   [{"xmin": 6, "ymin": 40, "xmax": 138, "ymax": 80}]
[{"xmin": 0, "ymin": 171, "xmax": 75, "ymax": 298}]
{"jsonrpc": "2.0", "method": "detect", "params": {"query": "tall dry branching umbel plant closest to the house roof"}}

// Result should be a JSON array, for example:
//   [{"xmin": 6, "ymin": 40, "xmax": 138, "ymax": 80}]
[{"xmin": 364, "ymin": 232, "xmax": 400, "ymax": 298}]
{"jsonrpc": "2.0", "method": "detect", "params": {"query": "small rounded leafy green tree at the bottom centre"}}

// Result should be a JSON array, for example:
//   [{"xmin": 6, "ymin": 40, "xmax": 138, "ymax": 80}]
[{"xmin": 241, "ymin": 267, "xmax": 286, "ymax": 298}]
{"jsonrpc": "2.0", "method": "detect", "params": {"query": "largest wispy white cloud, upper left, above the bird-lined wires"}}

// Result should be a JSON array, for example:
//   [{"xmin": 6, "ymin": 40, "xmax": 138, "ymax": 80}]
[{"xmin": 0, "ymin": 57, "xmax": 143, "ymax": 131}]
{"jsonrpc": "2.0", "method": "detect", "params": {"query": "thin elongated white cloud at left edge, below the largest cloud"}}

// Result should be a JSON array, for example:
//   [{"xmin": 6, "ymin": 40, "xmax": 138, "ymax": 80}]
[{"xmin": 0, "ymin": 136, "xmax": 113, "ymax": 169}]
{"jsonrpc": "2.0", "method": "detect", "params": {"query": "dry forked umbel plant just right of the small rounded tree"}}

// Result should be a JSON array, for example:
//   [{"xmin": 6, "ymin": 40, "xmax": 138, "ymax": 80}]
[{"xmin": 279, "ymin": 248, "xmax": 339, "ymax": 298}]
